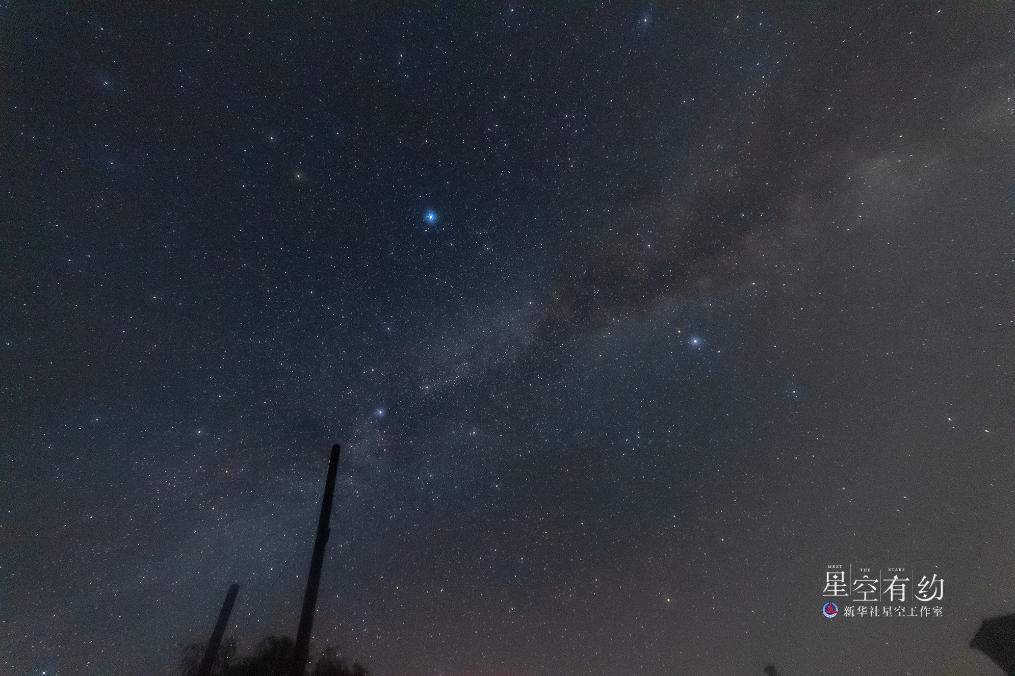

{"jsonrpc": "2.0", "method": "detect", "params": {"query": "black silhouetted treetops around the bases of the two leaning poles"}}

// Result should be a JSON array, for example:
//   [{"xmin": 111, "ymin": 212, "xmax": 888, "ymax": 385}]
[{"xmin": 180, "ymin": 635, "xmax": 369, "ymax": 676}]
